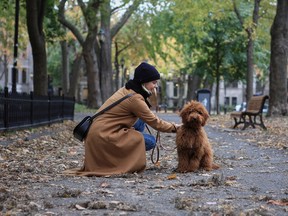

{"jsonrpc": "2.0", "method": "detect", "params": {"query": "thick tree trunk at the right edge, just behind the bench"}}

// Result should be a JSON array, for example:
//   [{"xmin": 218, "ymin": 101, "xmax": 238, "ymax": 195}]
[{"xmin": 268, "ymin": 0, "xmax": 288, "ymax": 116}]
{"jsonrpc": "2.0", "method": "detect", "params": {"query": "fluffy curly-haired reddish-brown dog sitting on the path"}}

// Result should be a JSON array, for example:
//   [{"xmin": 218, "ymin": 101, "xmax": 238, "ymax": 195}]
[{"xmin": 176, "ymin": 100, "xmax": 219, "ymax": 172}]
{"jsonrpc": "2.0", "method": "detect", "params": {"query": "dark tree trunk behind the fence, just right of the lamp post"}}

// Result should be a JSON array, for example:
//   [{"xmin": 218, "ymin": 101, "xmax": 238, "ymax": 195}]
[{"xmin": 26, "ymin": 0, "xmax": 48, "ymax": 95}]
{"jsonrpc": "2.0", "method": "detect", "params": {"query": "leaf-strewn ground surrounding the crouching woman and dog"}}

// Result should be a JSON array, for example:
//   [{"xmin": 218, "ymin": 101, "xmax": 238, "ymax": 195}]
[{"xmin": 0, "ymin": 113, "xmax": 288, "ymax": 216}]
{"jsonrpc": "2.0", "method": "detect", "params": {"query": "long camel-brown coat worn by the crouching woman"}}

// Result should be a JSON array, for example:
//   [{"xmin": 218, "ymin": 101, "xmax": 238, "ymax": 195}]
[{"xmin": 70, "ymin": 87, "xmax": 176, "ymax": 176}]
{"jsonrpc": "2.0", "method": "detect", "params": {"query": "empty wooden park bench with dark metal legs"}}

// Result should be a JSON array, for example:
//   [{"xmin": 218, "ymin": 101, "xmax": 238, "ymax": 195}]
[{"xmin": 230, "ymin": 95, "xmax": 269, "ymax": 130}]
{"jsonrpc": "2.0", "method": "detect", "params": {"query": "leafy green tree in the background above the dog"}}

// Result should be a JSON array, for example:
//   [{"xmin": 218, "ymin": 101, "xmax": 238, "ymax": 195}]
[{"xmin": 144, "ymin": 1, "xmax": 245, "ymax": 113}]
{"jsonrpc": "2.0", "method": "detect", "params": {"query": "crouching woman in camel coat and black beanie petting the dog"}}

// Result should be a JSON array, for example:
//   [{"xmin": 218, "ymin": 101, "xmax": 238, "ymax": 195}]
[{"xmin": 66, "ymin": 62, "xmax": 178, "ymax": 176}]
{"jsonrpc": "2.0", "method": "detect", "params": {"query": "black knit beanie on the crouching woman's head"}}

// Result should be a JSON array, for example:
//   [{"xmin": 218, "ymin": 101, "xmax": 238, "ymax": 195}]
[{"xmin": 133, "ymin": 62, "xmax": 160, "ymax": 83}]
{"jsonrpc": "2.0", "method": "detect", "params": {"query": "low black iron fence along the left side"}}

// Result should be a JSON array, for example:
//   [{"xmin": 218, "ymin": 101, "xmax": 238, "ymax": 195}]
[{"xmin": 0, "ymin": 88, "xmax": 75, "ymax": 131}]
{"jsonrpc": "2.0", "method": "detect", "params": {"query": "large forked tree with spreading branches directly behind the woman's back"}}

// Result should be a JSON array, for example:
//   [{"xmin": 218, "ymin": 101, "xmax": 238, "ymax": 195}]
[{"xmin": 58, "ymin": 0, "xmax": 141, "ymax": 108}]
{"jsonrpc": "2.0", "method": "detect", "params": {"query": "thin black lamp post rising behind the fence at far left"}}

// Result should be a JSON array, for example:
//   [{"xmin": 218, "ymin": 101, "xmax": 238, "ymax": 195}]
[{"xmin": 12, "ymin": 0, "xmax": 19, "ymax": 93}]
